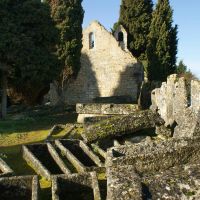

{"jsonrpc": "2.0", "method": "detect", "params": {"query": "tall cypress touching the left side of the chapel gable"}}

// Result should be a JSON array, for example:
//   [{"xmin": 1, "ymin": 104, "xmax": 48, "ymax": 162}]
[{"xmin": 47, "ymin": 0, "xmax": 84, "ymax": 85}]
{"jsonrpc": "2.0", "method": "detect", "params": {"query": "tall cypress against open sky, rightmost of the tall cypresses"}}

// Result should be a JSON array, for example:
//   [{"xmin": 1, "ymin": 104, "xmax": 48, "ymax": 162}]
[{"xmin": 147, "ymin": 0, "xmax": 178, "ymax": 81}]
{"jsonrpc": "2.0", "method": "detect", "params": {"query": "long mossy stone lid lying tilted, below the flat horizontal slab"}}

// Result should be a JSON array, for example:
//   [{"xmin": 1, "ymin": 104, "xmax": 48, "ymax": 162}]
[{"xmin": 82, "ymin": 110, "xmax": 163, "ymax": 142}]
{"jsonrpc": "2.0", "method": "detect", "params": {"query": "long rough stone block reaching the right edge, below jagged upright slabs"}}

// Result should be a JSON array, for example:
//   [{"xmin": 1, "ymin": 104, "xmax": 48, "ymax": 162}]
[{"xmin": 106, "ymin": 137, "xmax": 200, "ymax": 173}]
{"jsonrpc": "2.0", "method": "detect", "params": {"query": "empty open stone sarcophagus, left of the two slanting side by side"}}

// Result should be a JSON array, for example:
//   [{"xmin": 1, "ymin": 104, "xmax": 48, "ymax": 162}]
[{"xmin": 23, "ymin": 143, "xmax": 71, "ymax": 180}]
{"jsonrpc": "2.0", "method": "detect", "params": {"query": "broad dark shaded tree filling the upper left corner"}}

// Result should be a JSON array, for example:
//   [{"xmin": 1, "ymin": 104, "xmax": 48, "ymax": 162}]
[{"xmin": 0, "ymin": 0, "xmax": 59, "ymax": 117}]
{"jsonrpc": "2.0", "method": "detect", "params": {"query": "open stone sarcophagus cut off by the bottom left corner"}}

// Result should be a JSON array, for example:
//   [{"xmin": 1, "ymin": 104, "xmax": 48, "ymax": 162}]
[{"xmin": 0, "ymin": 176, "xmax": 40, "ymax": 200}]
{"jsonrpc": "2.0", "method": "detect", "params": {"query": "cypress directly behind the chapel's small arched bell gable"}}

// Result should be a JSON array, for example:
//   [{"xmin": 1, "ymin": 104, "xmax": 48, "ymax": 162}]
[{"xmin": 119, "ymin": 0, "xmax": 153, "ymax": 60}]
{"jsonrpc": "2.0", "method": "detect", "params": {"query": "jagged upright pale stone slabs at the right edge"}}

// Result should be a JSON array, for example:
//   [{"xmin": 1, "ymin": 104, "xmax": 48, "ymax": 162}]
[{"xmin": 151, "ymin": 74, "xmax": 200, "ymax": 137}]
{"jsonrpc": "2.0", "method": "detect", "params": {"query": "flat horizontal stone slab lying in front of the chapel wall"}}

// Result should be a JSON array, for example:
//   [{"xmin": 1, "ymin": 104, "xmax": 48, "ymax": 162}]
[{"xmin": 76, "ymin": 103, "xmax": 138, "ymax": 115}]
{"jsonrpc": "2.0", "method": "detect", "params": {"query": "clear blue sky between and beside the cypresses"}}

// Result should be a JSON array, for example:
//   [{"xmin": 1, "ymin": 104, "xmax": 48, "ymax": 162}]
[{"xmin": 83, "ymin": 0, "xmax": 200, "ymax": 78}]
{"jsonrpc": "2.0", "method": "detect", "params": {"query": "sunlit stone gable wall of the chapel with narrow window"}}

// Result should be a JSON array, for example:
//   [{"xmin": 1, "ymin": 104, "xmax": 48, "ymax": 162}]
[{"xmin": 64, "ymin": 21, "xmax": 143, "ymax": 104}]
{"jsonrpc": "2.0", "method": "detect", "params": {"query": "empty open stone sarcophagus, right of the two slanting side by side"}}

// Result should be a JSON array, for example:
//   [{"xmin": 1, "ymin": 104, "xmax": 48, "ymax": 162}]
[{"xmin": 55, "ymin": 140, "xmax": 103, "ymax": 173}]
